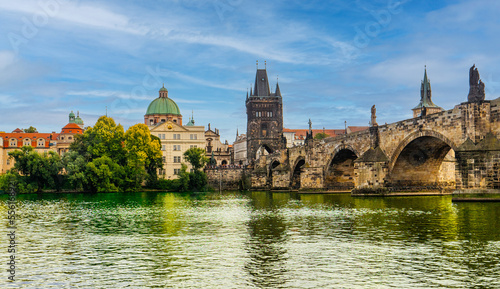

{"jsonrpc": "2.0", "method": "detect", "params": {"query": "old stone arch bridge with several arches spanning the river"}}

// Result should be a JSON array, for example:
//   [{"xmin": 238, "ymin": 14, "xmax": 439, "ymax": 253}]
[{"xmin": 251, "ymin": 98, "xmax": 500, "ymax": 192}]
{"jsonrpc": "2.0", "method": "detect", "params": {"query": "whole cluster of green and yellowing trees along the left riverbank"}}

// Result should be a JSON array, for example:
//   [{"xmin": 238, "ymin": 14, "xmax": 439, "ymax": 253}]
[{"xmin": 3, "ymin": 116, "xmax": 162, "ymax": 192}]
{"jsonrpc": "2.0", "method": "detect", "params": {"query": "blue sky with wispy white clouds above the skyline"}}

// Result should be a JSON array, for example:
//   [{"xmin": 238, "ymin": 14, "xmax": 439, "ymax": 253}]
[{"xmin": 0, "ymin": 0, "xmax": 500, "ymax": 142}]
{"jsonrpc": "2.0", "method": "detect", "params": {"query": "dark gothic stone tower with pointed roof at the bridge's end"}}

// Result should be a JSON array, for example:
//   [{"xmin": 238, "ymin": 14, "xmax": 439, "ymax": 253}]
[{"xmin": 246, "ymin": 68, "xmax": 285, "ymax": 163}]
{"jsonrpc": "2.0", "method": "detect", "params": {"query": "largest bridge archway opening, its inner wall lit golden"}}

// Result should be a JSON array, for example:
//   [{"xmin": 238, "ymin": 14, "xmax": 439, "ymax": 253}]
[{"xmin": 389, "ymin": 136, "xmax": 456, "ymax": 190}]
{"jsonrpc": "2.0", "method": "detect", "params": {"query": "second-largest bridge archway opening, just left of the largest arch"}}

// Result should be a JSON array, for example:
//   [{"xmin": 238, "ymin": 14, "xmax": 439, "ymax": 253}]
[{"xmin": 325, "ymin": 148, "xmax": 358, "ymax": 190}]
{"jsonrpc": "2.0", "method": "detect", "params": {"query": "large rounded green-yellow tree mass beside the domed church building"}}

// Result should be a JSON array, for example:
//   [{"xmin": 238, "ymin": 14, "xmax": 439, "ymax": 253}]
[{"xmin": 65, "ymin": 116, "xmax": 162, "ymax": 192}]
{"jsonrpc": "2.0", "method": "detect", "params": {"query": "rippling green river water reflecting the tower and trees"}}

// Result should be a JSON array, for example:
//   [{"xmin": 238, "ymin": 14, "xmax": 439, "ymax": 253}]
[{"xmin": 0, "ymin": 192, "xmax": 500, "ymax": 288}]
